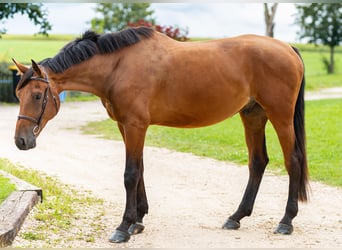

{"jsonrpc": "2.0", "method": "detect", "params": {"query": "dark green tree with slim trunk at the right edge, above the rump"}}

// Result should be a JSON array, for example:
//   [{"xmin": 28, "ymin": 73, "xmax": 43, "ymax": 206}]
[{"xmin": 296, "ymin": 3, "xmax": 342, "ymax": 74}]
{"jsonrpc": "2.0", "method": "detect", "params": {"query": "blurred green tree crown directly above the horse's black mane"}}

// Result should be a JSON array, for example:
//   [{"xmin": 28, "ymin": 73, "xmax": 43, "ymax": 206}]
[{"xmin": 90, "ymin": 3, "xmax": 154, "ymax": 33}]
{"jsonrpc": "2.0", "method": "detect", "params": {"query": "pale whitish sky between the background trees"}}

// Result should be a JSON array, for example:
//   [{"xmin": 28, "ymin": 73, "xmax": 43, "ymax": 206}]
[{"xmin": 0, "ymin": 3, "xmax": 299, "ymax": 42}]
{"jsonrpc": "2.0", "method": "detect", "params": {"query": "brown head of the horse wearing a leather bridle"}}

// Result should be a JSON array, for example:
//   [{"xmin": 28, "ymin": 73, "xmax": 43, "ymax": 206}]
[{"xmin": 13, "ymin": 60, "xmax": 60, "ymax": 150}]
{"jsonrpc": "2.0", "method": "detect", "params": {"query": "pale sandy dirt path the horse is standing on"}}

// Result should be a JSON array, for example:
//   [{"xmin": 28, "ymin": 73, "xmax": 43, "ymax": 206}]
[{"xmin": 0, "ymin": 89, "xmax": 342, "ymax": 248}]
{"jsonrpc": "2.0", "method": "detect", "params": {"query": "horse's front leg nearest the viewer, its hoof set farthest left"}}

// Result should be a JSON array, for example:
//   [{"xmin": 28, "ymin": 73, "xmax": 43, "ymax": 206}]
[{"xmin": 109, "ymin": 126, "xmax": 147, "ymax": 243}]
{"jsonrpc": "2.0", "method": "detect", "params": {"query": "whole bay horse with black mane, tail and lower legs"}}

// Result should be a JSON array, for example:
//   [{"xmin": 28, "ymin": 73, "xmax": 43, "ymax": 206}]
[{"xmin": 14, "ymin": 27, "xmax": 308, "ymax": 242}]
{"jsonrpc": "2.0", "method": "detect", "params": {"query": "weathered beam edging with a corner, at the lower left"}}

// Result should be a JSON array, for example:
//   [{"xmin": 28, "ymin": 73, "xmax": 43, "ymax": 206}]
[{"xmin": 0, "ymin": 170, "xmax": 42, "ymax": 247}]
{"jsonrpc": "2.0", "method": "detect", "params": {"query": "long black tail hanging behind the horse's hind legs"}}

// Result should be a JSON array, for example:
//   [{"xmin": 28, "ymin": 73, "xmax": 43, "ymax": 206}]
[{"xmin": 293, "ymin": 47, "xmax": 309, "ymax": 201}]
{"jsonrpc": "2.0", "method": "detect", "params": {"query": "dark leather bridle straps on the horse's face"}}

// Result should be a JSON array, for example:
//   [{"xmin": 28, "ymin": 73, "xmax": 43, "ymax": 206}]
[{"xmin": 18, "ymin": 68, "xmax": 58, "ymax": 135}]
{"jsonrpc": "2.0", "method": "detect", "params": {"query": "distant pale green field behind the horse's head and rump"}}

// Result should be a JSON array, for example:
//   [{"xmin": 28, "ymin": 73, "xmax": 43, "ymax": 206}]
[{"xmin": 0, "ymin": 35, "xmax": 342, "ymax": 90}]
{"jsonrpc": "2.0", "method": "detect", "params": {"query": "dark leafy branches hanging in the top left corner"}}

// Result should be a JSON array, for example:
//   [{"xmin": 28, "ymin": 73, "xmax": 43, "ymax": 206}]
[{"xmin": 0, "ymin": 3, "xmax": 51, "ymax": 35}]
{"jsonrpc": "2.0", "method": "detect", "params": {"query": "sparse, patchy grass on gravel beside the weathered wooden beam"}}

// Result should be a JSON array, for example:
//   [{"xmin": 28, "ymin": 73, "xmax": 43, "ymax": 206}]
[{"xmin": 0, "ymin": 159, "xmax": 104, "ymax": 247}]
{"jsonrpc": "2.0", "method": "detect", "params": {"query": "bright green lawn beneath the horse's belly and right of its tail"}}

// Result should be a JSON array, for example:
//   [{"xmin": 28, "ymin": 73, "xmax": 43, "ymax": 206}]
[{"xmin": 83, "ymin": 99, "xmax": 342, "ymax": 187}]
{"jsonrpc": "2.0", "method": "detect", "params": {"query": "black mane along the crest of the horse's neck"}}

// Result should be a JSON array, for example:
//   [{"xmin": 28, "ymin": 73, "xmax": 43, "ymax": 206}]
[{"xmin": 41, "ymin": 27, "xmax": 153, "ymax": 73}]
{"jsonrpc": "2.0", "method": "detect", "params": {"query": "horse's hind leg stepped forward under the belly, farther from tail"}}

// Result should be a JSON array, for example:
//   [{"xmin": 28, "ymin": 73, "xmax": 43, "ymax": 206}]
[{"xmin": 223, "ymin": 102, "xmax": 268, "ymax": 229}]
